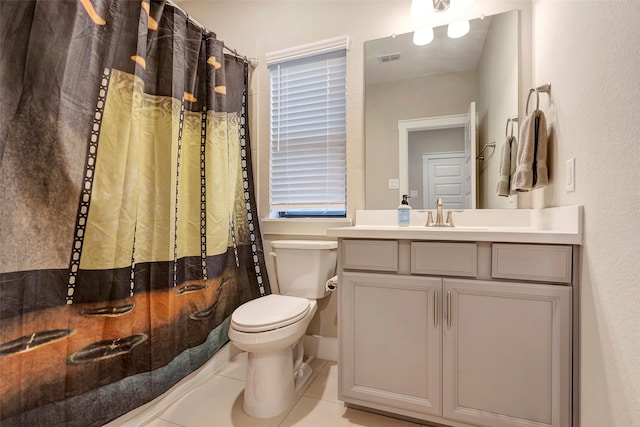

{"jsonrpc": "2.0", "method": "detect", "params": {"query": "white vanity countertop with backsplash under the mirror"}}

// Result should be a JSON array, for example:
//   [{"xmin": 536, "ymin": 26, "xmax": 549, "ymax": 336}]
[{"xmin": 327, "ymin": 206, "xmax": 583, "ymax": 245}]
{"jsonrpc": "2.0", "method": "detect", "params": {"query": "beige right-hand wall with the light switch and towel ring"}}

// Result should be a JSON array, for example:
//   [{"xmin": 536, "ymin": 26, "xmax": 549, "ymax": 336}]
[{"xmin": 532, "ymin": 0, "xmax": 640, "ymax": 427}]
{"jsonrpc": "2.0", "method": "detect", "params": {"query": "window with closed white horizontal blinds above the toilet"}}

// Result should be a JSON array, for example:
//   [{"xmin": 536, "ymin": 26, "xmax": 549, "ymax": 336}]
[{"xmin": 267, "ymin": 37, "xmax": 348, "ymax": 217}]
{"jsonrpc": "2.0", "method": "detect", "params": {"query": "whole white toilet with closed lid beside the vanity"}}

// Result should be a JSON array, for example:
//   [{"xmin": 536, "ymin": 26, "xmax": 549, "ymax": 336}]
[{"xmin": 229, "ymin": 240, "xmax": 337, "ymax": 418}]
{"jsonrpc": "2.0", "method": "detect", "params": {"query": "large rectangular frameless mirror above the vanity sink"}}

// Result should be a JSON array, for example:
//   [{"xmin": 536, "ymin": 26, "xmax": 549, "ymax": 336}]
[{"xmin": 364, "ymin": 10, "xmax": 520, "ymax": 209}]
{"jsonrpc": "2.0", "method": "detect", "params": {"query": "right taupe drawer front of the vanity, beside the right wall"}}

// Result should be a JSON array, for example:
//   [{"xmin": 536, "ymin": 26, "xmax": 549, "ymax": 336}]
[{"xmin": 491, "ymin": 243, "xmax": 572, "ymax": 283}]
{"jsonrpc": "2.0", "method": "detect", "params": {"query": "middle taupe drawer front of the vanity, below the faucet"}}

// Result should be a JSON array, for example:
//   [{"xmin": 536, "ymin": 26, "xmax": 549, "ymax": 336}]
[{"xmin": 411, "ymin": 242, "xmax": 478, "ymax": 277}]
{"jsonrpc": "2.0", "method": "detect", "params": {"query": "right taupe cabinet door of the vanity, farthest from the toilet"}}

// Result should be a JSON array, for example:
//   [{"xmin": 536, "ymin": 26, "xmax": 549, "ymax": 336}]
[{"xmin": 443, "ymin": 279, "xmax": 571, "ymax": 427}]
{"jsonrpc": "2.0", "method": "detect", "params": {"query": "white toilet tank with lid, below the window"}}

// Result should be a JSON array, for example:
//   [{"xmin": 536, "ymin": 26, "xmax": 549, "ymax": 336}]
[{"xmin": 271, "ymin": 240, "xmax": 338, "ymax": 299}]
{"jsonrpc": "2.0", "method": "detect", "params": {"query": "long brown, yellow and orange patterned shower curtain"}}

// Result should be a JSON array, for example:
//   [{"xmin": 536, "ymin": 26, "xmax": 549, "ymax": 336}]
[{"xmin": 0, "ymin": 0, "xmax": 270, "ymax": 427}]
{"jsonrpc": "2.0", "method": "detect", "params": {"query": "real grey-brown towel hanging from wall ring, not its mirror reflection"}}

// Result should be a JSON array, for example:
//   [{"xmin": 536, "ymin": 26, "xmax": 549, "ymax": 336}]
[{"xmin": 512, "ymin": 110, "xmax": 549, "ymax": 191}]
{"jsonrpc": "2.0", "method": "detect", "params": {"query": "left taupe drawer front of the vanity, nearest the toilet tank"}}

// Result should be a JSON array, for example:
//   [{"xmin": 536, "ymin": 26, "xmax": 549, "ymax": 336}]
[{"xmin": 342, "ymin": 239, "xmax": 398, "ymax": 271}]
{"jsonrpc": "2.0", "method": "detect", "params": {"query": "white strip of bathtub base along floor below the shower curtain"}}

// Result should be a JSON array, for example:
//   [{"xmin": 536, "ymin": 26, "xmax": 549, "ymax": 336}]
[{"xmin": 103, "ymin": 342, "xmax": 241, "ymax": 427}]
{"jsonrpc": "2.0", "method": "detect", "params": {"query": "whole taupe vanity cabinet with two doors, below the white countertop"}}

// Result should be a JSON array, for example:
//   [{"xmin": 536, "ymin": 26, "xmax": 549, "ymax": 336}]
[{"xmin": 338, "ymin": 239, "xmax": 572, "ymax": 427}]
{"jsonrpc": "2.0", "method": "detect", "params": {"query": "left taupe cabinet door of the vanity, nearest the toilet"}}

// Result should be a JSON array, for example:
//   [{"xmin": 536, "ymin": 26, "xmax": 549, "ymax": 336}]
[{"xmin": 338, "ymin": 272, "xmax": 442, "ymax": 415}]
